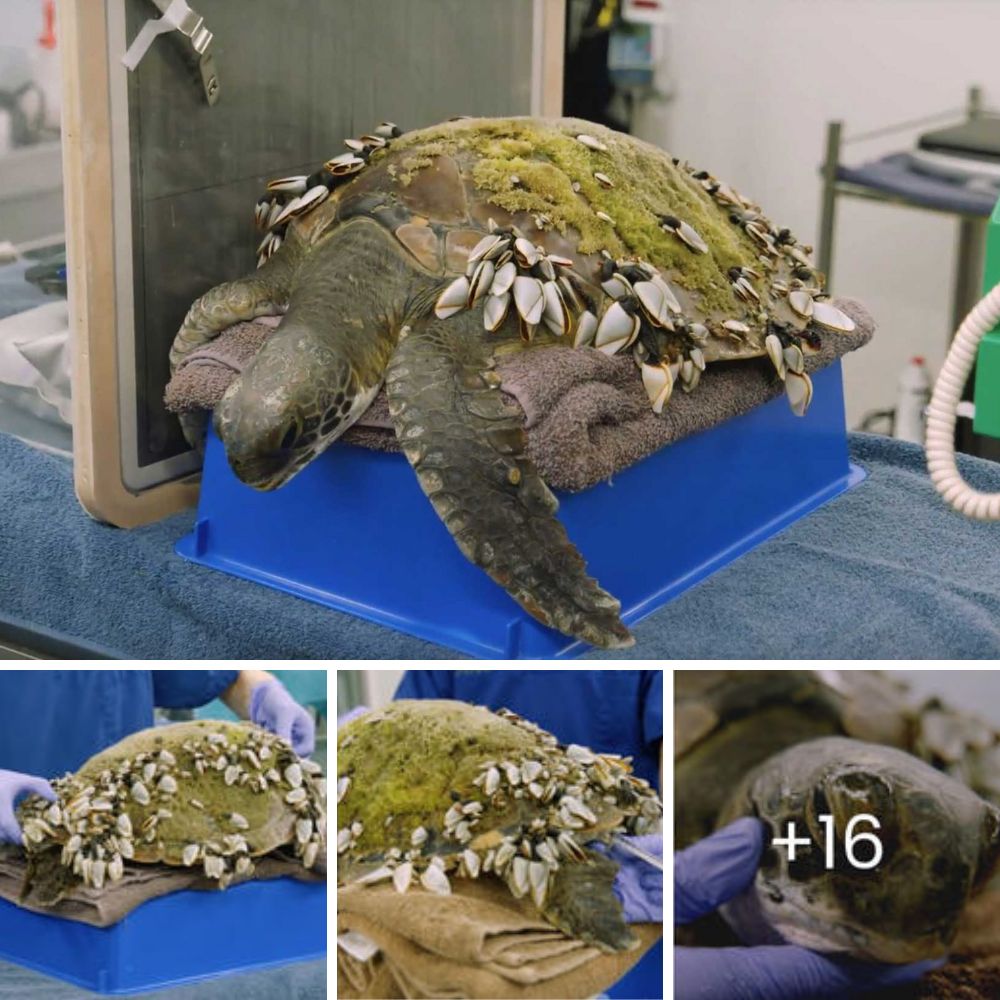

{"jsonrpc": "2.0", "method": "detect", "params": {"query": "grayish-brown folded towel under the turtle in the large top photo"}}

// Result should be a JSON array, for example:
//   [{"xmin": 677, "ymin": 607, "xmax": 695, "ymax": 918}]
[{"xmin": 165, "ymin": 299, "xmax": 875, "ymax": 491}]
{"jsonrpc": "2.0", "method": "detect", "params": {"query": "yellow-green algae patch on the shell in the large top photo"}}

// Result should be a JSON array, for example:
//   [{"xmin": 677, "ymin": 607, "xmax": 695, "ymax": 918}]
[{"xmin": 370, "ymin": 118, "xmax": 760, "ymax": 315}]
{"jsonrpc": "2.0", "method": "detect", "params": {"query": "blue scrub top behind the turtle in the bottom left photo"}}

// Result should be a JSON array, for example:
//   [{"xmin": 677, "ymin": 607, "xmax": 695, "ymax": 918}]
[{"xmin": 0, "ymin": 670, "xmax": 239, "ymax": 778}]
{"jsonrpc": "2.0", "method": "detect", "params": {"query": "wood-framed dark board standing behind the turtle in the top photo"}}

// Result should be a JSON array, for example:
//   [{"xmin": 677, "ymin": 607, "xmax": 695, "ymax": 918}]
[{"xmin": 59, "ymin": 0, "xmax": 565, "ymax": 527}]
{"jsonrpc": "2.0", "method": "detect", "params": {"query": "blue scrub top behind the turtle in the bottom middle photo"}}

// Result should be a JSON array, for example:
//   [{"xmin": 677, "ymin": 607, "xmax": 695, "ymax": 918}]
[{"xmin": 395, "ymin": 670, "xmax": 663, "ymax": 788}]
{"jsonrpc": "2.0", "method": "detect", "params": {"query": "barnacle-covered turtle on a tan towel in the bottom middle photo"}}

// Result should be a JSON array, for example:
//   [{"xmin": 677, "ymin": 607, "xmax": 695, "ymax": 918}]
[{"xmin": 337, "ymin": 700, "xmax": 662, "ymax": 951}]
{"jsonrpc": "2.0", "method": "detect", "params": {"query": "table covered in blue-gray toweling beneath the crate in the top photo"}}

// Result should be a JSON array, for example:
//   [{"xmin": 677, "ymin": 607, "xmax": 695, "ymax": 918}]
[{"xmin": 0, "ymin": 434, "xmax": 1000, "ymax": 659}]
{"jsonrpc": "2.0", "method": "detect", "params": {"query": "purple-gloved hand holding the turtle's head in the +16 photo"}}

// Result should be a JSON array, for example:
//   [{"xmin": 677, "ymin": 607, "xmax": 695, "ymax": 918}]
[{"xmin": 674, "ymin": 818, "xmax": 942, "ymax": 1000}]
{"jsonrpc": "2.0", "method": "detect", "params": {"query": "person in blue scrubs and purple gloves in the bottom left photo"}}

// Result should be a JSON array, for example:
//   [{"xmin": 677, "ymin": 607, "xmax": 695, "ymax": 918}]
[{"xmin": 0, "ymin": 670, "xmax": 316, "ymax": 843}]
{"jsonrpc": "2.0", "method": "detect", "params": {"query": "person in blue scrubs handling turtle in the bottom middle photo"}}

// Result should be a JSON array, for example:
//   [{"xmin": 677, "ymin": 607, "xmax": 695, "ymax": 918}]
[{"xmin": 395, "ymin": 670, "xmax": 663, "ymax": 997}]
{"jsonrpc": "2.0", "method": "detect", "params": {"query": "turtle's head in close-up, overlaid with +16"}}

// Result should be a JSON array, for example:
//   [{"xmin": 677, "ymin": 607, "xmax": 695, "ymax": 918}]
[{"xmin": 724, "ymin": 737, "xmax": 1000, "ymax": 963}]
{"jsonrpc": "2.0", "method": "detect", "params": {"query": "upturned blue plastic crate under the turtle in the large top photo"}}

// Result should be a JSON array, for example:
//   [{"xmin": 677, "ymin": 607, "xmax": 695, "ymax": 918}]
[{"xmin": 177, "ymin": 362, "xmax": 864, "ymax": 659}]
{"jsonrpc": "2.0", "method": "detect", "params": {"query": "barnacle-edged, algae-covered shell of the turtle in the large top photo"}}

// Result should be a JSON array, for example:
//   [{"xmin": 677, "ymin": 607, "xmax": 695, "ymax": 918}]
[{"xmin": 274, "ymin": 118, "xmax": 853, "ymax": 372}]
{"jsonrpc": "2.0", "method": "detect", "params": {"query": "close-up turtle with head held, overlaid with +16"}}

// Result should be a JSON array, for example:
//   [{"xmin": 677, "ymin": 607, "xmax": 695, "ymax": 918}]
[{"xmin": 675, "ymin": 671, "xmax": 1000, "ymax": 962}]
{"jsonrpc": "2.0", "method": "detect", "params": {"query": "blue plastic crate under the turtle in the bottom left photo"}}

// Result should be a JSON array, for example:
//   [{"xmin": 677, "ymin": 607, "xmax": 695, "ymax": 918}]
[{"xmin": 0, "ymin": 878, "xmax": 326, "ymax": 995}]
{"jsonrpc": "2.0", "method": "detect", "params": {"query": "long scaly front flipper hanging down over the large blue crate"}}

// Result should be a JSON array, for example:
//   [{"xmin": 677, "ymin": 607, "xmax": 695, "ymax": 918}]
[{"xmin": 386, "ymin": 313, "xmax": 633, "ymax": 648}]
